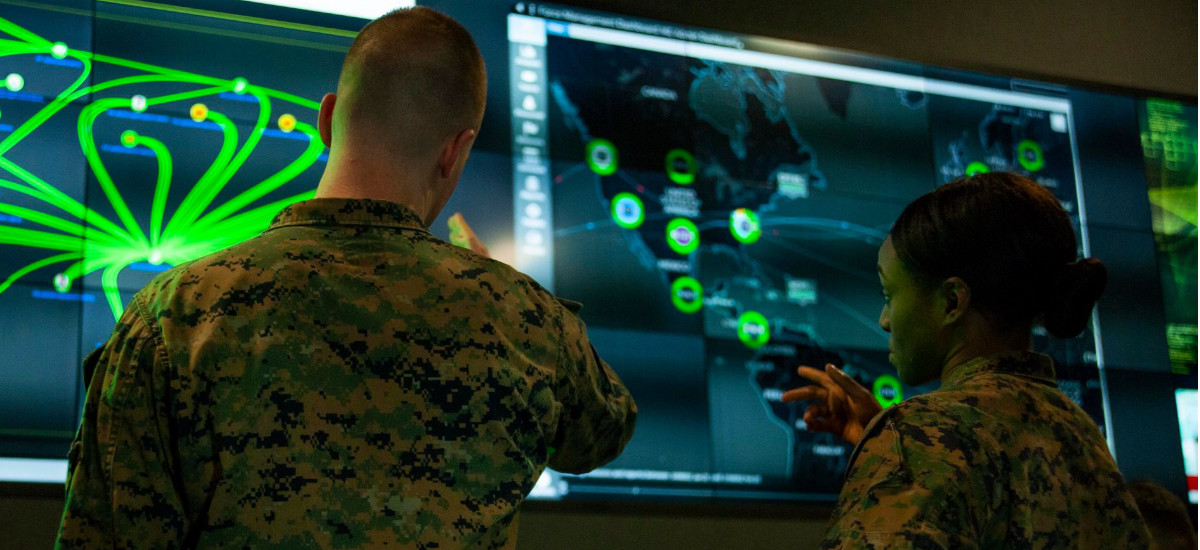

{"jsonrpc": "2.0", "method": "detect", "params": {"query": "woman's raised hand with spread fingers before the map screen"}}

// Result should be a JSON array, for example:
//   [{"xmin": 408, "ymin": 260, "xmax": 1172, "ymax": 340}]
[{"xmin": 784, "ymin": 365, "xmax": 883, "ymax": 444}]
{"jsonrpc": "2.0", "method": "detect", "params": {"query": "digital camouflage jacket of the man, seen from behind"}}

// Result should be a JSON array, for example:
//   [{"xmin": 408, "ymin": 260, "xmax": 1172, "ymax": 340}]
[{"xmin": 59, "ymin": 199, "xmax": 636, "ymax": 549}]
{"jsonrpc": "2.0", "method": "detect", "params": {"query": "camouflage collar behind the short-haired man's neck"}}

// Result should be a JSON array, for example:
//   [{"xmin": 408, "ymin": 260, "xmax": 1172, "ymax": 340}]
[{"xmin": 270, "ymin": 198, "xmax": 428, "ymax": 232}]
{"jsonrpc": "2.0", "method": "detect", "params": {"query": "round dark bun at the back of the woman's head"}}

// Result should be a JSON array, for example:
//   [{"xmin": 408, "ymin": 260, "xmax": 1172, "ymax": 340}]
[{"xmin": 1042, "ymin": 258, "xmax": 1109, "ymax": 339}]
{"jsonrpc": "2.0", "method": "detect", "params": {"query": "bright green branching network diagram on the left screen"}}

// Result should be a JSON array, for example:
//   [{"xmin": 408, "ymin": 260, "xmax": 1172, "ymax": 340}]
[{"xmin": 0, "ymin": 18, "xmax": 325, "ymax": 318}]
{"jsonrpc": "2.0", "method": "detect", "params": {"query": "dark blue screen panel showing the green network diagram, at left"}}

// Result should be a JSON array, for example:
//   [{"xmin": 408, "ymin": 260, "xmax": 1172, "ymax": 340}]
[{"xmin": 0, "ymin": 1, "xmax": 354, "ymax": 478}]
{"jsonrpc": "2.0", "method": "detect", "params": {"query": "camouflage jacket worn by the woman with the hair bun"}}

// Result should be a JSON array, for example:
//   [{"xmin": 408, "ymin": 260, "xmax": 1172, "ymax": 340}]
[{"xmin": 822, "ymin": 353, "xmax": 1150, "ymax": 549}]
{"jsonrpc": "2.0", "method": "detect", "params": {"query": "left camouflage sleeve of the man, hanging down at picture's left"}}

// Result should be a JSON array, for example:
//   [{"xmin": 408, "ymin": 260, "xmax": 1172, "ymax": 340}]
[{"xmin": 55, "ymin": 299, "xmax": 187, "ymax": 549}]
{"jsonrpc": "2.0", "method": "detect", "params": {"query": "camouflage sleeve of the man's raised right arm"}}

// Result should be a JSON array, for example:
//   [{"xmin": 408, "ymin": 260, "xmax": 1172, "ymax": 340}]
[{"xmin": 550, "ymin": 300, "xmax": 637, "ymax": 473}]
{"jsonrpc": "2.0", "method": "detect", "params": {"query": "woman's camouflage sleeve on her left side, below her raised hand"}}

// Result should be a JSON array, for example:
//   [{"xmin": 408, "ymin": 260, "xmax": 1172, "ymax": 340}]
[{"xmin": 821, "ymin": 407, "xmax": 990, "ymax": 549}]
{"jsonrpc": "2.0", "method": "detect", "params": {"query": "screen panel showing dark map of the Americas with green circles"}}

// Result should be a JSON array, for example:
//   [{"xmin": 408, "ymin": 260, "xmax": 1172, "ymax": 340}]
[{"xmin": 509, "ymin": 4, "xmax": 1104, "ymax": 500}]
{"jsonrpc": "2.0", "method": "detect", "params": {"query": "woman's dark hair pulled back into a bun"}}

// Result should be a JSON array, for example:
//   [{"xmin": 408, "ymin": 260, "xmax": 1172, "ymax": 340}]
[{"xmin": 892, "ymin": 172, "xmax": 1108, "ymax": 337}]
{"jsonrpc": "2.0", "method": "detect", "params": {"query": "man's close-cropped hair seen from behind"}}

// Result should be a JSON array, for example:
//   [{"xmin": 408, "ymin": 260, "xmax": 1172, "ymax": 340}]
[{"xmin": 335, "ymin": 7, "xmax": 487, "ymax": 154}]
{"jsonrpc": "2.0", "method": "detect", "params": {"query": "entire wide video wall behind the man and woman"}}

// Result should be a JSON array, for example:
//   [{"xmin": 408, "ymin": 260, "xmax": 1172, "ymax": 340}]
[{"xmin": 0, "ymin": 0, "xmax": 1195, "ymax": 501}]
